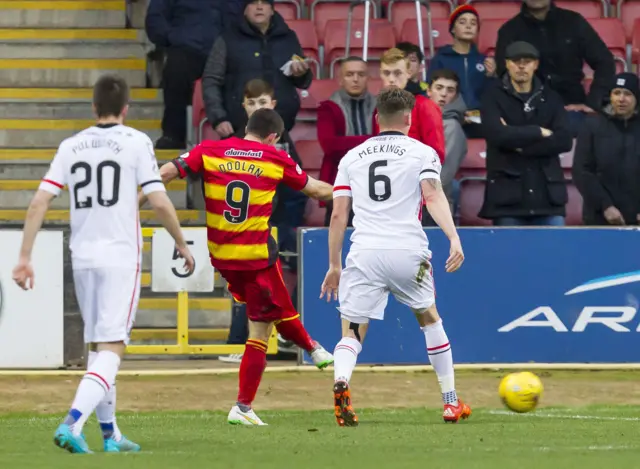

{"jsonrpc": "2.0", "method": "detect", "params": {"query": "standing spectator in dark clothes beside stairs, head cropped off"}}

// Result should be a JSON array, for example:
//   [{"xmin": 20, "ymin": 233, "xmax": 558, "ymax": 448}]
[{"xmin": 145, "ymin": 0, "xmax": 222, "ymax": 149}]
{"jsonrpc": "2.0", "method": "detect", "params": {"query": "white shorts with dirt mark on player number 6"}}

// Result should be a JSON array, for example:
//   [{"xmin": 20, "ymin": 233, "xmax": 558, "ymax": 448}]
[{"xmin": 338, "ymin": 249, "xmax": 435, "ymax": 324}]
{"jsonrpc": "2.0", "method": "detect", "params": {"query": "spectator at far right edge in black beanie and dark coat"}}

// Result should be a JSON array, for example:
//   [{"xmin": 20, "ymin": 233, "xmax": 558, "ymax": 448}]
[{"xmin": 573, "ymin": 73, "xmax": 640, "ymax": 225}]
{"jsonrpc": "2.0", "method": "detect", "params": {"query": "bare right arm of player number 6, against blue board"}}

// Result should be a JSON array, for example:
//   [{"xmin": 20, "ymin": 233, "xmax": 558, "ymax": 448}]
[{"xmin": 420, "ymin": 179, "xmax": 464, "ymax": 272}]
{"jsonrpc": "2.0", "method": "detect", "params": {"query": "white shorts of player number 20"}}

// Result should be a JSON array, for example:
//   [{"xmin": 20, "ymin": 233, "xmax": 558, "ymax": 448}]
[{"xmin": 73, "ymin": 267, "xmax": 140, "ymax": 344}]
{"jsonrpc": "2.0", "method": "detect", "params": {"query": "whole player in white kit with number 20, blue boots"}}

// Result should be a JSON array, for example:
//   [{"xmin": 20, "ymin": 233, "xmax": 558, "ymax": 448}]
[{"xmin": 13, "ymin": 76, "xmax": 194, "ymax": 453}]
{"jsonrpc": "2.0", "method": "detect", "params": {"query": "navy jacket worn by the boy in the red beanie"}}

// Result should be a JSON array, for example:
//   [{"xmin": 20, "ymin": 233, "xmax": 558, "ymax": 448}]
[{"xmin": 427, "ymin": 44, "xmax": 491, "ymax": 109}]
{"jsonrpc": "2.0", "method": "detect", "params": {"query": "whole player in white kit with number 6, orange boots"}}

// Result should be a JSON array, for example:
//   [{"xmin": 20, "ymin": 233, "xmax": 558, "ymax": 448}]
[{"xmin": 321, "ymin": 89, "xmax": 471, "ymax": 426}]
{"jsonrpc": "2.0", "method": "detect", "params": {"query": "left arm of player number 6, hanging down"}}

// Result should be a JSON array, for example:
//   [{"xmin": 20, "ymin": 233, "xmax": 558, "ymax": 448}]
[{"xmin": 320, "ymin": 196, "xmax": 351, "ymax": 301}]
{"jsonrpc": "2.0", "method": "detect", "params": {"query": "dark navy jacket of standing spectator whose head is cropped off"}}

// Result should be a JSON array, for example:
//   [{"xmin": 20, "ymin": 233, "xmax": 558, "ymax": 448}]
[{"xmin": 145, "ymin": 0, "xmax": 223, "ymax": 57}]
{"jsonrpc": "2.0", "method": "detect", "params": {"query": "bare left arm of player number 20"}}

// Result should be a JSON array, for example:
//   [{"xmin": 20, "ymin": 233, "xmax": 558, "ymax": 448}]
[{"xmin": 13, "ymin": 190, "xmax": 55, "ymax": 290}]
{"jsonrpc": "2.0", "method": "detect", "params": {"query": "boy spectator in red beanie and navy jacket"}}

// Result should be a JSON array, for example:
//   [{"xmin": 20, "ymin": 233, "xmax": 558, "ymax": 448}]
[{"xmin": 427, "ymin": 5, "xmax": 496, "ymax": 138}]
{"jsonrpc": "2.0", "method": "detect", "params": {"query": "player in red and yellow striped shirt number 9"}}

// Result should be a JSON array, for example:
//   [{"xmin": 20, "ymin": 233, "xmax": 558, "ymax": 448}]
[{"xmin": 147, "ymin": 109, "xmax": 333, "ymax": 425}]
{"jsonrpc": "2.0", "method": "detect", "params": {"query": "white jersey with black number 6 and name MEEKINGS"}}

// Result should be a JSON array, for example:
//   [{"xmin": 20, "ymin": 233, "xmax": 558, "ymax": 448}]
[{"xmin": 333, "ymin": 132, "xmax": 441, "ymax": 251}]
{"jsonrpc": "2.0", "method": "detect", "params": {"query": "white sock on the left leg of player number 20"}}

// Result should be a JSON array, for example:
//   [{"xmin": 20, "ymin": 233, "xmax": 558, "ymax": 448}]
[{"xmin": 65, "ymin": 351, "xmax": 120, "ymax": 436}]
